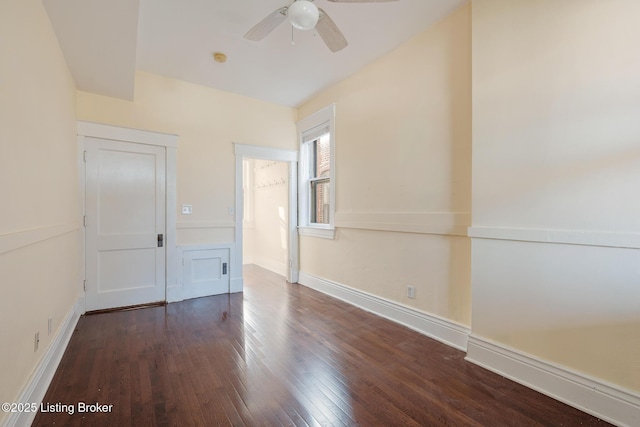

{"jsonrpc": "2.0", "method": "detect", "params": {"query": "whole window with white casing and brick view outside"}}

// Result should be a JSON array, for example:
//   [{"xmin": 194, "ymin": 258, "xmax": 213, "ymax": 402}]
[{"xmin": 298, "ymin": 105, "xmax": 335, "ymax": 239}]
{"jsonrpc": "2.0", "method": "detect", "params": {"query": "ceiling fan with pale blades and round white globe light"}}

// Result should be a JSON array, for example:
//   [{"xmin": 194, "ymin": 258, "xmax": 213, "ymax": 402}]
[{"xmin": 244, "ymin": 0, "xmax": 398, "ymax": 52}]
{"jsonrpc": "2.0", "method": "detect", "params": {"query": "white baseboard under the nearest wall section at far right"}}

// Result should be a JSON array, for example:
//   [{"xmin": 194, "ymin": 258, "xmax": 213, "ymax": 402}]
[{"xmin": 466, "ymin": 335, "xmax": 640, "ymax": 427}]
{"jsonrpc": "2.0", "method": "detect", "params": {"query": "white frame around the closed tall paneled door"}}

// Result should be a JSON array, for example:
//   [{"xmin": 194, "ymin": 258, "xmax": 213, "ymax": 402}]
[{"xmin": 76, "ymin": 120, "xmax": 178, "ymax": 313}]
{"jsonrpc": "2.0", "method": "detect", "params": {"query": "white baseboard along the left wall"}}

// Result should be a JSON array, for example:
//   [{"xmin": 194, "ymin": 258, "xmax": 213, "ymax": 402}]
[{"xmin": 4, "ymin": 298, "xmax": 83, "ymax": 427}]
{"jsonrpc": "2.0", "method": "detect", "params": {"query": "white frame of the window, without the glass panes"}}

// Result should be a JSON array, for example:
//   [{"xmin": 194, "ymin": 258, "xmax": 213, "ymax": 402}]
[{"xmin": 297, "ymin": 104, "xmax": 336, "ymax": 239}]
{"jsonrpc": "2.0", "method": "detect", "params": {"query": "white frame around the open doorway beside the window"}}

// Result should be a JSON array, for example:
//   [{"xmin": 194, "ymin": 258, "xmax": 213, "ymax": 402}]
[{"xmin": 234, "ymin": 143, "xmax": 300, "ymax": 292}]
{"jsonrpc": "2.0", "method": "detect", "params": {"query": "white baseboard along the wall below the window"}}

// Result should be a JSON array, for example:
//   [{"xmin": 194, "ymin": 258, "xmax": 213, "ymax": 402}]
[{"xmin": 298, "ymin": 271, "xmax": 471, "ymax": 351}]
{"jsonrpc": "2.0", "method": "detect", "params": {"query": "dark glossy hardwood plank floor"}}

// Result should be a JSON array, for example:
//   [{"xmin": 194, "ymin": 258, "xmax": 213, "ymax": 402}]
[{"xmin": 33, "ymin": 266, "xmax": 608, "ymax": 427}]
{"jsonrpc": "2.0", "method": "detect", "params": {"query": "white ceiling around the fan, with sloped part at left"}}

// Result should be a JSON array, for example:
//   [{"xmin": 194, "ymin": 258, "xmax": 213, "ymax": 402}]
[{"xmin": 43, "ymin": 0, "xmax": 467, "ymax": 106}]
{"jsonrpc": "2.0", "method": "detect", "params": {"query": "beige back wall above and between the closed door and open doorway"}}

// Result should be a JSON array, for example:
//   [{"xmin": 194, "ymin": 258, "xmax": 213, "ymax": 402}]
[{"xmin": 78, "ymin": 71, "xmax": 296, "ymax": 245}]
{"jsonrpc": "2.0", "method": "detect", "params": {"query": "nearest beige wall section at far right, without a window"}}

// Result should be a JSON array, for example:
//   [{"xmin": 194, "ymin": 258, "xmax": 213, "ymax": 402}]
[{"xmin": 472, "ymin": 0, "xmax": 640, "ymax": 391}]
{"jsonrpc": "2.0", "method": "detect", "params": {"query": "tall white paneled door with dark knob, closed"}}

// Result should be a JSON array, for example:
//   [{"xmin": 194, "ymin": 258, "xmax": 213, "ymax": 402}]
[{"xmin": 85, "ymin": 138, "xmax": 166, "ymax": 311}]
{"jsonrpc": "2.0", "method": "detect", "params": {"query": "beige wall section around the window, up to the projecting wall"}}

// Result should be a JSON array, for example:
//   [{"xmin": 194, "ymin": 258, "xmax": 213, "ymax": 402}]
[{"xmin": 298, "ymin": 5, "xmax": 471, "ymax": 325}]
